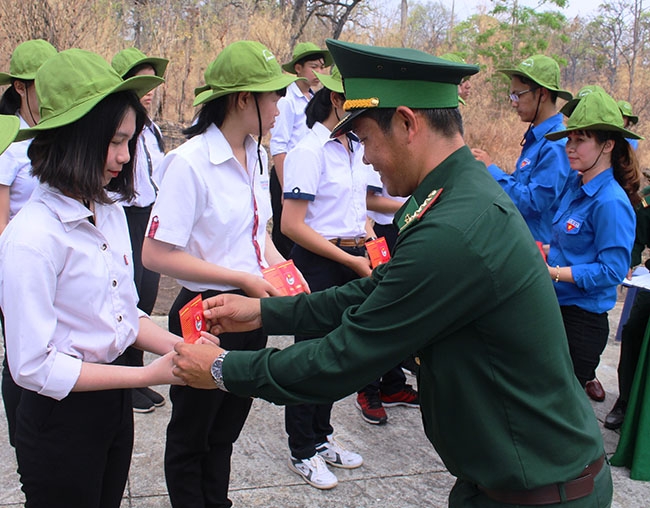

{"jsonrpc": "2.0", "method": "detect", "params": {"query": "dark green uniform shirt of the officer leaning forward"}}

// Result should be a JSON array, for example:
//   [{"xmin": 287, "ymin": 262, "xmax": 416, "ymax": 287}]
[{"xmin": 223, "ymin": 147, "xmax": 603, "ymax": 490}]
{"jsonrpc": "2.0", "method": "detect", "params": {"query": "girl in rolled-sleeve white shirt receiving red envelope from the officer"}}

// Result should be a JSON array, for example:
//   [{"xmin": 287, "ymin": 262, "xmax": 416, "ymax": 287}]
[{"xmin": 0, "ymin": 49, "xmax": 178, "ymax": 508}]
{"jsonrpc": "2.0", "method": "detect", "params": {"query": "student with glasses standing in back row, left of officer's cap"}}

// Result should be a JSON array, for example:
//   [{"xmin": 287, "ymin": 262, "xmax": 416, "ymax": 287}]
[{"xmin": 270, "ymin": 42, "xmax": 332, "ymax": 257}]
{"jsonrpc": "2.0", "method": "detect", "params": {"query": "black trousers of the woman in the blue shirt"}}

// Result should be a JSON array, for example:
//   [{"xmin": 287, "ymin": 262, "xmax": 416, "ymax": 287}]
[{"xmin": 560, "ymin": 305, "xmax": 609, "ymax": 386}]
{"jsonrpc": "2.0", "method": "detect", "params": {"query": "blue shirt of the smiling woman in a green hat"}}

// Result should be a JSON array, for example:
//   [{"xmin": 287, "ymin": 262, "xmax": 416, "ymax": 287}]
[{"xmin": 548, "ymin": 168, "xmax": 636, "ymax": 314}]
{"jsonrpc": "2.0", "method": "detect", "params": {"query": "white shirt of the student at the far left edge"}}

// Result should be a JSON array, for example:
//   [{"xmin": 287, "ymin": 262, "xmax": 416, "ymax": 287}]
[{"xmin": 0, "ymin": 115, "xmax": 38, "ymax": 220}]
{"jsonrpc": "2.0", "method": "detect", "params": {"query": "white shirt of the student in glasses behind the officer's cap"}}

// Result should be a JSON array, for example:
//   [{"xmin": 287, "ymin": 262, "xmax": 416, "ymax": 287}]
[{"xmin": 270, "ymin": 82, "xmax": 309, "ymax": 155}]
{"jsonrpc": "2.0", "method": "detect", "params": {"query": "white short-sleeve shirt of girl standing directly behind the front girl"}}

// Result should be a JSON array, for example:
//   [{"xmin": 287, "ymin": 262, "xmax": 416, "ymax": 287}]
[{"xmin": 147, "ymin": 124, "xmax": 271, "ymax": 292}]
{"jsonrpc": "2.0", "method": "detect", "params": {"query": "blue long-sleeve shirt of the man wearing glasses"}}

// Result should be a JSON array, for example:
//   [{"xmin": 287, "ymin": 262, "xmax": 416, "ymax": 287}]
[{"xmin": 488, "ymin": 113, "xmax": 571, "ymax": 243}]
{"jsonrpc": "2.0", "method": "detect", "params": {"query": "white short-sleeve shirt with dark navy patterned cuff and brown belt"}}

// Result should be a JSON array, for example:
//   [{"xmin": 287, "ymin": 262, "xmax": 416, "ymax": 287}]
[{"xmin": 283, "ymin": 122, "xmax": 374, "ymax": 240}]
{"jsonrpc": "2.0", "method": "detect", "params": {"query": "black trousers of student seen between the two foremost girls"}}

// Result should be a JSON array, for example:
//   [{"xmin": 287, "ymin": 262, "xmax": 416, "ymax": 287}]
[{"xmin": 124, "ymin": 206, "xmax": 160, "ymax": 367}]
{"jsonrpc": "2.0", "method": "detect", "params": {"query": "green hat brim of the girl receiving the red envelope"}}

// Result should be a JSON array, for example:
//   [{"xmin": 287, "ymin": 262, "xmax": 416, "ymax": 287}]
[{"xmin": 16, "ymin": 75, "xmax": 165, "ymax": 141}]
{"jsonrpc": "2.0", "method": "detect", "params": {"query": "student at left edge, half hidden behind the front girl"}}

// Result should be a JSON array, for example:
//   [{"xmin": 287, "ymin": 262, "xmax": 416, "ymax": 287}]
[{"xmin": 0, "ymin": 39, "xmax": 57, "ymax": 446}]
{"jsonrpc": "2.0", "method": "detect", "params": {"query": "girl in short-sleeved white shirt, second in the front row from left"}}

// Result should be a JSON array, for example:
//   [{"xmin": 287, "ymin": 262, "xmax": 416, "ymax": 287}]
[{"xmin": 142, "ymin": 41, "xmax": 297, "ymax": 508}]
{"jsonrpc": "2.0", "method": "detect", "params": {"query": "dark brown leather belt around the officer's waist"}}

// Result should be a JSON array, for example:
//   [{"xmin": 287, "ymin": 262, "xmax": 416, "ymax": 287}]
[{"xmin": 478, "ymin": 455, "xmax": 605, "ymax": 506}]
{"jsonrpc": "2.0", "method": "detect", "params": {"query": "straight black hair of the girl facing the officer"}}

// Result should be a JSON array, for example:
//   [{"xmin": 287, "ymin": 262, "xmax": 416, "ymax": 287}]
[{"xmin": 27, "ymin": 90, "xmax": 147, "ymax": 203}]
